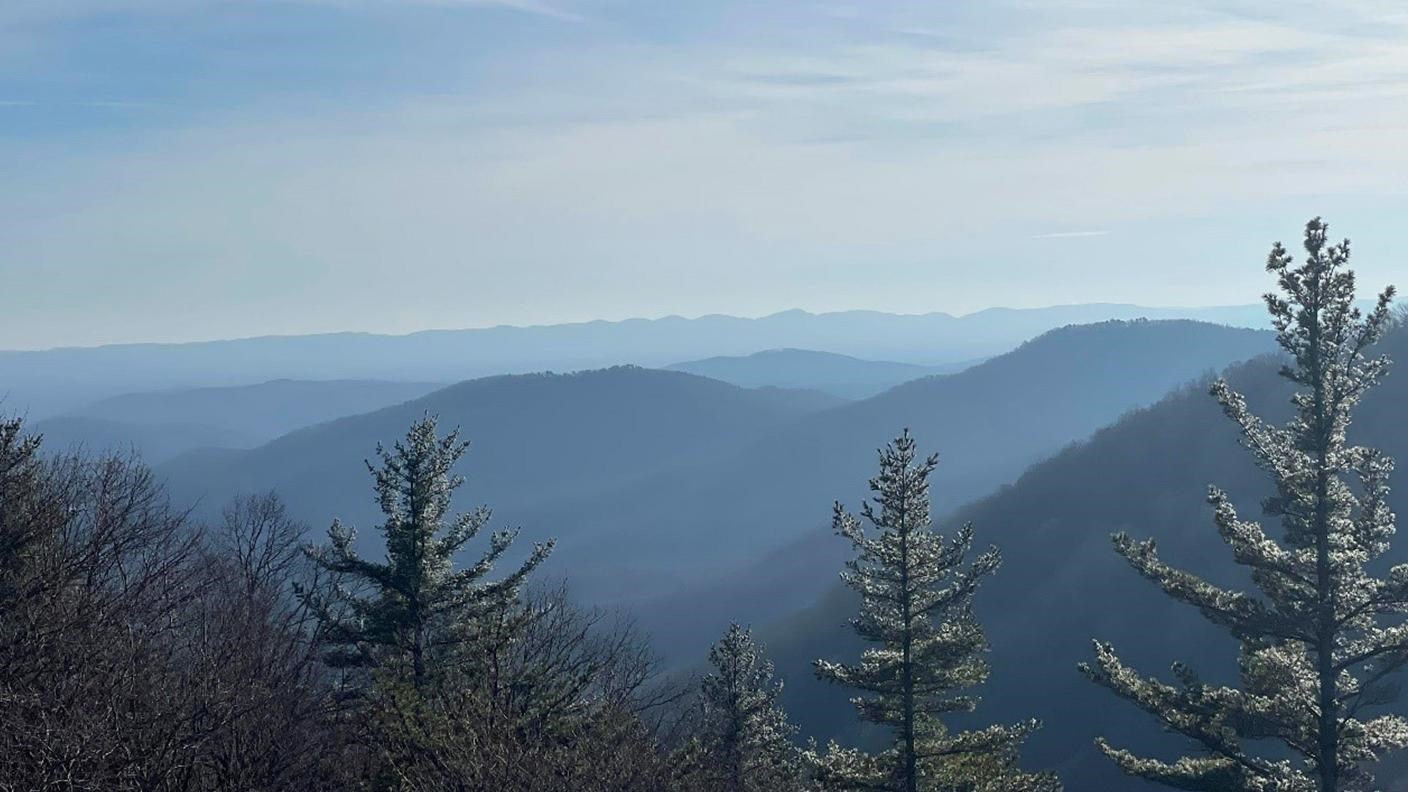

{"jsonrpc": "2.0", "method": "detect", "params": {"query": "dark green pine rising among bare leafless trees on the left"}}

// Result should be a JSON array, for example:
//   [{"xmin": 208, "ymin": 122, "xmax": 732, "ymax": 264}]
[{"xmin": 303, "ymin": 417, "xmax": 552, "ymax": 689}]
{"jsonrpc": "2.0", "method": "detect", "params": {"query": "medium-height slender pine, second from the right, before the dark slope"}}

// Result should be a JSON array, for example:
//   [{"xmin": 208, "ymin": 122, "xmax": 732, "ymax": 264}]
[{"xmin": 808, "ymin": 430, "xmax": 1060, "ymax": 792}]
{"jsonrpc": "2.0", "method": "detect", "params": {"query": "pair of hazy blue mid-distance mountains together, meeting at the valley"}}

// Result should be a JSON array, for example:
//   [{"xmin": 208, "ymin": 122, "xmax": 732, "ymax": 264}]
[{"xmin": 161, "ymin": 321, "xmax": 1271, "ymax": 605}]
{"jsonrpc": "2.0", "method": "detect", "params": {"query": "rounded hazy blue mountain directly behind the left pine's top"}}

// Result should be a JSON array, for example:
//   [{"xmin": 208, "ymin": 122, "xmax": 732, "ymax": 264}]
[{"xmin": 159, "ymin": 366, "xmax": 834, "ymax": 549}]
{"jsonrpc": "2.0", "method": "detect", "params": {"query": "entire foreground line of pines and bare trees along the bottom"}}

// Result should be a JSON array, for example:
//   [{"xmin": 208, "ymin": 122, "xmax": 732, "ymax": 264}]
[{"xmin": 0, "ymin": 218, "xmax": 1408, "ymax": 792}]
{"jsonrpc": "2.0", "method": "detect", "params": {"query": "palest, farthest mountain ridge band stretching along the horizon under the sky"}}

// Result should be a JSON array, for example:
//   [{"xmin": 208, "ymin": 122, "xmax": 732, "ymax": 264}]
[{"xmin": 0, "ymin": 304, "xmax": 1264, "ymax": 419}]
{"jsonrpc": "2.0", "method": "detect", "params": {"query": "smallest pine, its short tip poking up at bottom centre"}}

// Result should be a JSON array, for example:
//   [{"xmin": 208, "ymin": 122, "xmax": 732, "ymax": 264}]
[{"xmin": 683, "ymin": 624, "xmax": 800, "ymax": 792}]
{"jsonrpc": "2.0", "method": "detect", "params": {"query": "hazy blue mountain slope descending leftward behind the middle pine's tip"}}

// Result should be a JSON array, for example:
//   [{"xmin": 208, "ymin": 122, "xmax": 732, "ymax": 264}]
[{"xmin": 566, "ymin": 321, "xmax": 1274, "ymax": 605}]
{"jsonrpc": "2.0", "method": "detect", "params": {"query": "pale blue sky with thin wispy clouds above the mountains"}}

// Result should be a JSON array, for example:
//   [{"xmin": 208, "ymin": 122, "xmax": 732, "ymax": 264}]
[{"xmin": 0, "ymin": 0, "xmax": 1408, "ymax": 349}]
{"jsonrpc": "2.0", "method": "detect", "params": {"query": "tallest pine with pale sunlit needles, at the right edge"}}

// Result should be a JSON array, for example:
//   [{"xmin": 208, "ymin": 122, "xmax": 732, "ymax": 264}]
[{"xmin": 1081, "ymin": 218, "xmax": 1408, "ymax": 792}]
